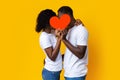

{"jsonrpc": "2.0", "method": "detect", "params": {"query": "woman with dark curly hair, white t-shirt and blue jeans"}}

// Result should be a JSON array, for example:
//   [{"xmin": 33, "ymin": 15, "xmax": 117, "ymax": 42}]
[{"xmin": 36, "ymin": 9, "xmax": 62, "ymax": 80}]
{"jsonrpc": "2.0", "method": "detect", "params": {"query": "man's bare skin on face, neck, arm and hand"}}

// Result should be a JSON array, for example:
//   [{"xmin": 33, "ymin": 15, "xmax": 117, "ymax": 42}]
[{"xmin": 58, "ymin": 12, "xmax": 87, "ymax": 59}]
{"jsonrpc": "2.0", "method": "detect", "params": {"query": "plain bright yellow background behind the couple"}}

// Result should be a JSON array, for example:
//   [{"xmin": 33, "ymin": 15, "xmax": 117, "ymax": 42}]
[{"xmin": 0, "ymin": 0, "xmax": 120, "ymax": 80}]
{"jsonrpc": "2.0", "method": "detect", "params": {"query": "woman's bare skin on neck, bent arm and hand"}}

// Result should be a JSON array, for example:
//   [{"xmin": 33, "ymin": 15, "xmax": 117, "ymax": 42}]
[{"xmin": 44, "ymin": 28, "xmax": 61, "ymax": 63}]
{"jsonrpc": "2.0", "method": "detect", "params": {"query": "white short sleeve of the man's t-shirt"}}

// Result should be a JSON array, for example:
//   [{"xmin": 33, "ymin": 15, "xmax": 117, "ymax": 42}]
[{"xmin": 77, "ymin": 28, "xmax": 88, "ymax": 46}]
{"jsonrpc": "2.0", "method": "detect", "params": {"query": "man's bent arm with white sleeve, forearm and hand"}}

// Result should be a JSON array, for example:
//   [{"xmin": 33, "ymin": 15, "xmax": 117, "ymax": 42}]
[{"xmin": 62, "ymin": 29, "xmax": 88, "ymax": 59}]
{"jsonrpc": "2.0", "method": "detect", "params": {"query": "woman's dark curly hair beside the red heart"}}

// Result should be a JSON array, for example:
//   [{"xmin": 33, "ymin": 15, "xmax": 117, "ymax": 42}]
[{"xmin": 36, "ymin": 9, "xmax": 56, "ymax": 32}]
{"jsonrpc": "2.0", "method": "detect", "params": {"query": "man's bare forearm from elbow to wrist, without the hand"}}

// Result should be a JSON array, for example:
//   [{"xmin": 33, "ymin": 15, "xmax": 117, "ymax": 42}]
[{"xmin": 63, "ymin": 40, "xmax": 83, "ymax": 59}]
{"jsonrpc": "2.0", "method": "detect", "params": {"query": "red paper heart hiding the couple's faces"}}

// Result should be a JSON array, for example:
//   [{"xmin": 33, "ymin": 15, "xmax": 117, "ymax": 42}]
[{"xmin": 50, "ymin": 14, "xmax": 70, "ymax": 30}]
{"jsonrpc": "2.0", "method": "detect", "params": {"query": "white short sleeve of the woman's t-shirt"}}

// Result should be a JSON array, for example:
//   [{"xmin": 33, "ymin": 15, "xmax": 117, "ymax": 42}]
[{"xmin": 39, "ymin": 35, "xmax": 52, "ymax": 49}]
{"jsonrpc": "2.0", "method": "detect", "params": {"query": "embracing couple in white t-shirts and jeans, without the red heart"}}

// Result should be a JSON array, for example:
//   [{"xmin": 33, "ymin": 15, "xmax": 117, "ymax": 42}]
[{"xmin": 36, "ymin": 6, "xmax": 88, "ymax": 80}]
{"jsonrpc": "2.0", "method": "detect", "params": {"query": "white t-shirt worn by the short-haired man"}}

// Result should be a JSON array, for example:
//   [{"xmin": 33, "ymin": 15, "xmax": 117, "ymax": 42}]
[{"xmin": 64, "ymin": 24, "xmax": 88, "ymax": 77}]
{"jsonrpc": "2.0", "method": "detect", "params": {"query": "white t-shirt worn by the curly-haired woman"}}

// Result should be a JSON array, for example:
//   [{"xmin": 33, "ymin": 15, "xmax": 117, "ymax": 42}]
[{"xmin": 39, "ymin": 32, "xmax": 62, "ymax": 71}]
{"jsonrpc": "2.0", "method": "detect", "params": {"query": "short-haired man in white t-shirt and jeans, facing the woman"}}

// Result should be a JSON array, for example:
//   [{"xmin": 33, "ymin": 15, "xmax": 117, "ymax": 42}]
[{"xmin": 58, "ymin": 6, "xmax": 88, "ymax": 80}]
